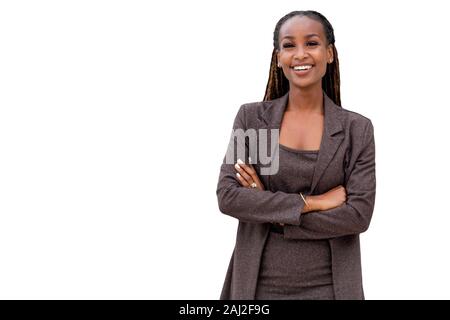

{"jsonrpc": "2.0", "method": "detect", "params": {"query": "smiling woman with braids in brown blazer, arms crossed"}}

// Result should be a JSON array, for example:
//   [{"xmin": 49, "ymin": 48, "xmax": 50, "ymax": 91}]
[{"xmin": 217, "ymin": 11, "xmax": 376, "ymax": 299}]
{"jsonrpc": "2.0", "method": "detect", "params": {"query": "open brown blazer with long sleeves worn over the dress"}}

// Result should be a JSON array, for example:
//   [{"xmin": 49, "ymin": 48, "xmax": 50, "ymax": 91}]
[{"xmin": 216, "ymin": 92, "xmax": 376, "ymax": 299}]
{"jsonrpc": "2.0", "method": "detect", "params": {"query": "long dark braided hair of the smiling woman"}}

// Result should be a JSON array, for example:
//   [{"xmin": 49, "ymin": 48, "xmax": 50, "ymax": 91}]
[{"xmin": 264, "ymin": 10, "xmax": 341, "ymax": 106}]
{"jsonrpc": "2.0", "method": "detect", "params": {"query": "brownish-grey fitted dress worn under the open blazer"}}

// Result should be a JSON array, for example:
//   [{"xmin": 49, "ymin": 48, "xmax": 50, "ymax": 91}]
[{"xmin": 255, "ymin": 144, "xmax": 335, "ymax": 300}]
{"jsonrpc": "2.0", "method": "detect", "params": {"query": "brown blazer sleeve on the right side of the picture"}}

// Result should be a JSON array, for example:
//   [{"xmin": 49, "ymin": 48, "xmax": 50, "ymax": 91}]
[{"xmin": 284, "ymin": 120, "xmax": 376, "ymax": 240}]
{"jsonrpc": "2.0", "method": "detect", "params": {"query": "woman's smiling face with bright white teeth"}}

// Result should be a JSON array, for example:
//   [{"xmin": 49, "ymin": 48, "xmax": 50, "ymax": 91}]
[{"xmin": 277, "ymin": 16, "xmax": 333, "ymax": 88}]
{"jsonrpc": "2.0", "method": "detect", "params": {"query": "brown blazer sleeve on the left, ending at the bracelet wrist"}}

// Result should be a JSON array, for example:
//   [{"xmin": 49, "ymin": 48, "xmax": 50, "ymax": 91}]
[{"xmin": 216, "ymin": 104, "xmax": 304, "ymax": 226}]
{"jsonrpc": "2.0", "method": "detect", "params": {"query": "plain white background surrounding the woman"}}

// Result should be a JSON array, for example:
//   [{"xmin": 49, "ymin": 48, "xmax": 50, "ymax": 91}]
[{"xmin": 0, "ymin": 0, "xmax": 450, "ymax": 299}]
